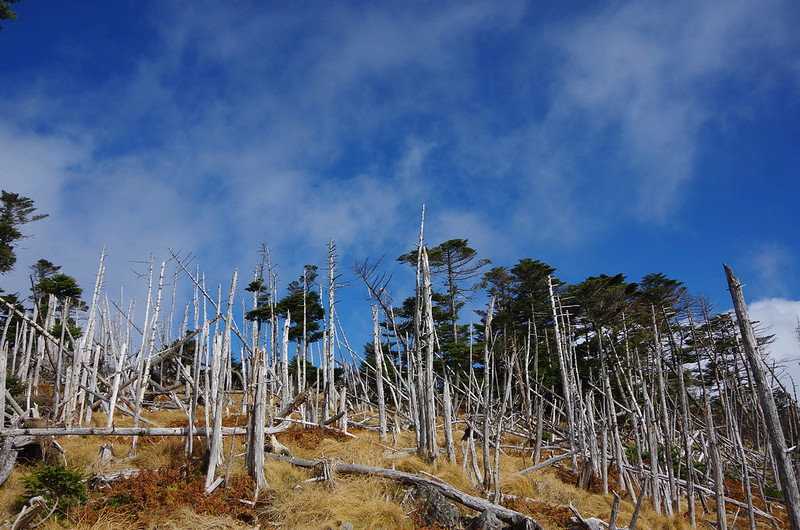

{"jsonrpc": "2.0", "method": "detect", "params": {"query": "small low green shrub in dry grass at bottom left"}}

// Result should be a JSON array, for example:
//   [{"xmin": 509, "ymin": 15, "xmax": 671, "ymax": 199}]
[{"xmin": 21, "ymin": 464, "xmax": 88, "ymax": 515}]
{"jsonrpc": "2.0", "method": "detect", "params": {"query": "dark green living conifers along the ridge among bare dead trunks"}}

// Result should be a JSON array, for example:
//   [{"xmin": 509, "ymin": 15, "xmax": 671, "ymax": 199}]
[{"xmin": 0, "ymin": 190, "xmax": 785, "ymax": 410}]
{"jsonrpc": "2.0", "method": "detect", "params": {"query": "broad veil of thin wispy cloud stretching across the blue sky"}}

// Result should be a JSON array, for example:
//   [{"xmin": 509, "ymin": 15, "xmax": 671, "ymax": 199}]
[{"xmin": 0, "ymin": 1, "xmax": 798, "ymax": 322}]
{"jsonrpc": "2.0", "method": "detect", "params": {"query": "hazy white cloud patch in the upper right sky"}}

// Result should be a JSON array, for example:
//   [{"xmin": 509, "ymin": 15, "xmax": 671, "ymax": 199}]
[{"xmin": 549, "ymin": 2, "xmax": 797, "ymax": 223}]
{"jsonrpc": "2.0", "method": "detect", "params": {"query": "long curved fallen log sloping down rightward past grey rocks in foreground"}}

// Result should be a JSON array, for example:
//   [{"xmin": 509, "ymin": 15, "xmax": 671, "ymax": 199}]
[{"xmin": 264, "ymin": 454, "xmax": 543, "ymax": 530}]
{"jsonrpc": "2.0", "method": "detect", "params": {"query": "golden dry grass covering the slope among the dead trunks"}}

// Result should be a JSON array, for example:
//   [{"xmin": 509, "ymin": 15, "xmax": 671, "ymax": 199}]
[{"xmin": 0, "ymin": 394, "xmax": 767, "ymax": 530}]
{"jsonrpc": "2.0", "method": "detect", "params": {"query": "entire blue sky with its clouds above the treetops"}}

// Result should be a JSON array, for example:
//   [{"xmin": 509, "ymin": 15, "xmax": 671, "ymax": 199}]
[{"xmin": 0, "ymin": 0, "xmax": 800, "ymax": 373}]
